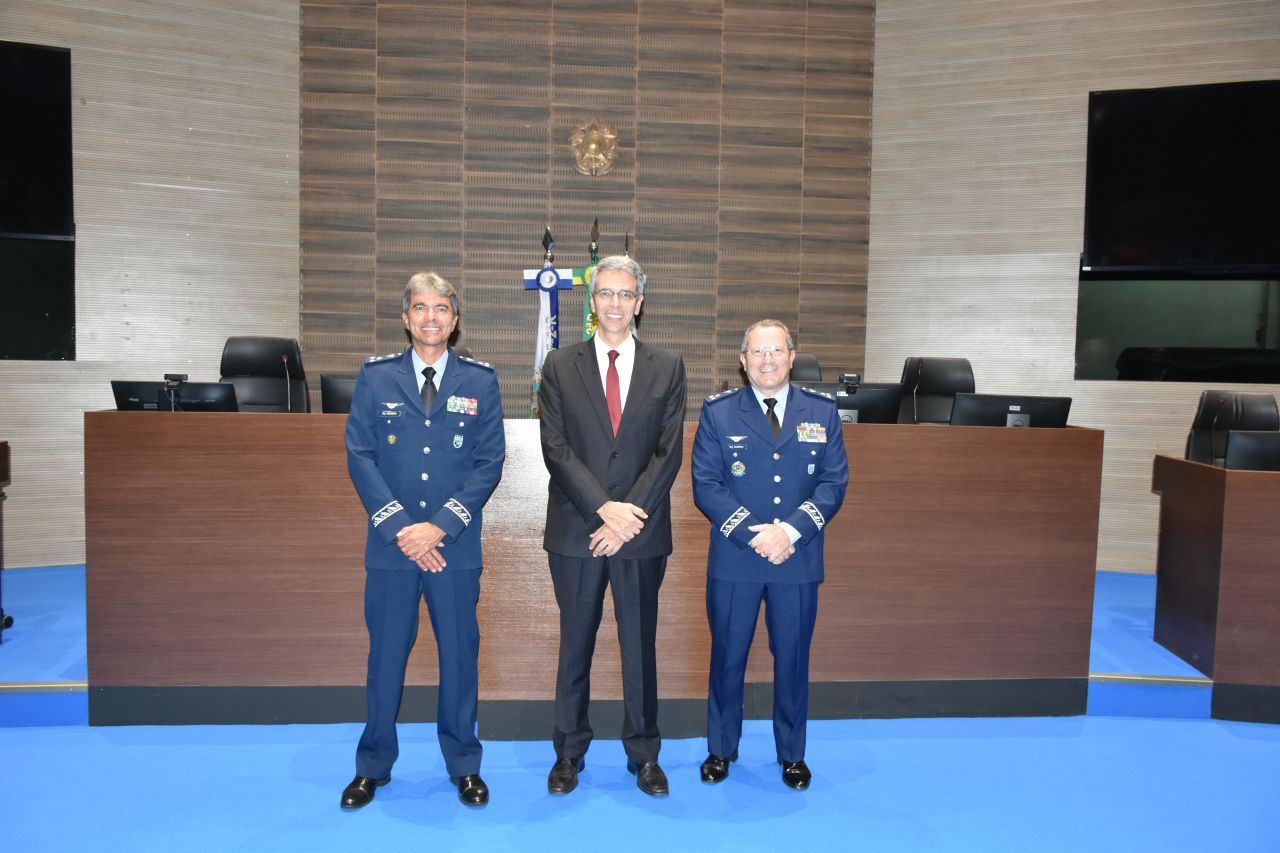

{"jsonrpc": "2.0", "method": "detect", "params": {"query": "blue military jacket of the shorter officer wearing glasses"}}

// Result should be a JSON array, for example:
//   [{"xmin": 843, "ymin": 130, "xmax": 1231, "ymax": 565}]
[{"xmin": 691, "ymin": 384, "xmax": 849, "ymax": 583}]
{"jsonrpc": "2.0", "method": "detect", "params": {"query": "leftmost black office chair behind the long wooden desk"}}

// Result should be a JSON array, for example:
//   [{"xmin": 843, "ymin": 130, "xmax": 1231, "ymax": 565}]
[{"xmin": 221, "ymin": 337, "xmax": 311, "ymax": 412}]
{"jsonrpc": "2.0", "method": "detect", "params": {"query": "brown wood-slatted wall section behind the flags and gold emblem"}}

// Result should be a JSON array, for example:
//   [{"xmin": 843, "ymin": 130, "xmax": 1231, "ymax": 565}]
[{"xmin": 301, "ymin": 0, "xmax": 874, "ymax": 419}]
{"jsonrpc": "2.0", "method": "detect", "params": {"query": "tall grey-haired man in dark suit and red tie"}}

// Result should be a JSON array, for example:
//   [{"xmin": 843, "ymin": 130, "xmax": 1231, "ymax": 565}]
[{"xmin": 538, "ymin": 255, "xmax": 685, "ymax": 797}]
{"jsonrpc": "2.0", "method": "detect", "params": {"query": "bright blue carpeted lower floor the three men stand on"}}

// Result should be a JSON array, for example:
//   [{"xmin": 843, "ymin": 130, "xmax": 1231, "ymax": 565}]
[{"xmin": 0, "ymin": 717, "xmax": 1280, "ymax": 853}]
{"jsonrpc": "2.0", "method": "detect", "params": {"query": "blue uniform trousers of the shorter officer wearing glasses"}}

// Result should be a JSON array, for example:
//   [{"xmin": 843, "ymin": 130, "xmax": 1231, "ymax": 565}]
[{"xmin": 707, "ymin": 578, "xmax": 818, "ymax": 761}]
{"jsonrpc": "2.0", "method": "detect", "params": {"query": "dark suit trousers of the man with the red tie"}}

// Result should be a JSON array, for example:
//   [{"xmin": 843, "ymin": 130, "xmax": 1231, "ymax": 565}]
[{"xmin": 547, "ymin": 553, "xmax": 667, "ymax": 765}]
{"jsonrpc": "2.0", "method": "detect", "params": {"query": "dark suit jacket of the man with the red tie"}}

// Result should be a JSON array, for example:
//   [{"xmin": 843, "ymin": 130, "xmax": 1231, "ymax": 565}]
[{"xmin": 538, "ymin": 339, "xmax": 685, "ymax": 560}]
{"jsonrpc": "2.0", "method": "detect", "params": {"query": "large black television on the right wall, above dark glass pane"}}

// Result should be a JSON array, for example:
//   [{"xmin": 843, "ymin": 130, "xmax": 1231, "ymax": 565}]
[{"xmin": 1080, "ymin": 81, "xmax": 1280, "ymax": 279}]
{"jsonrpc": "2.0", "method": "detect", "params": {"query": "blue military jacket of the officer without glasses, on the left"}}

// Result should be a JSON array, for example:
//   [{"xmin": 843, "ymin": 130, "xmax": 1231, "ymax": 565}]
[{"xmin": 347, "ymin": 350, "xmax": 507, "ymax": 571}]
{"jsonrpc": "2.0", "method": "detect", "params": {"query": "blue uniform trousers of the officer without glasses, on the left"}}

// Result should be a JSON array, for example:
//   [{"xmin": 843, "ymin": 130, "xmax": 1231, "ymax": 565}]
[{"xmin": 356, "ymin": 569, "xmax": 481, "ymax": 779}]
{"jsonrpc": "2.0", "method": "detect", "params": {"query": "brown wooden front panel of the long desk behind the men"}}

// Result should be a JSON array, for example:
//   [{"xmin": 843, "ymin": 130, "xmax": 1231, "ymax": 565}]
[{"xmin": 86, "ymin": 412, "xmax": 1102, "ymax": 699}]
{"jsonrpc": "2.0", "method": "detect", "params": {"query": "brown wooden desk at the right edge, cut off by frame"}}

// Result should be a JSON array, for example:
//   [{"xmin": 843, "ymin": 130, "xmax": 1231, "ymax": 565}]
[{"xmin": 1152, "ymin": 456, "xmax": 1280, "ymax": 722}]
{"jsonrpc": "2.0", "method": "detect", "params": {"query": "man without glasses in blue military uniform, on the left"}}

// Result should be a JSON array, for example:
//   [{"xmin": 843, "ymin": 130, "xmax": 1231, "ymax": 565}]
[{"xmin": 342, "ymin": 273, "xmax": 506, "ymax": 808}]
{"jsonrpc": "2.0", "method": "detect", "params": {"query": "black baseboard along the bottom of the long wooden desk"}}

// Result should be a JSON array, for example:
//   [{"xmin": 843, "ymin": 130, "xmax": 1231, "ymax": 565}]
[{"xmin": 88, "ymin": 678, "xmax": 1090, "ymax": 727}]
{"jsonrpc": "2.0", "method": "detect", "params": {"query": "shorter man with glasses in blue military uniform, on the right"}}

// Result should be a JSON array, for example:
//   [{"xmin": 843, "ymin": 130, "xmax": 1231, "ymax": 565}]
[{"xmin": 692, "ymin": 320, "xmax": 849, "ymax": 790}]
